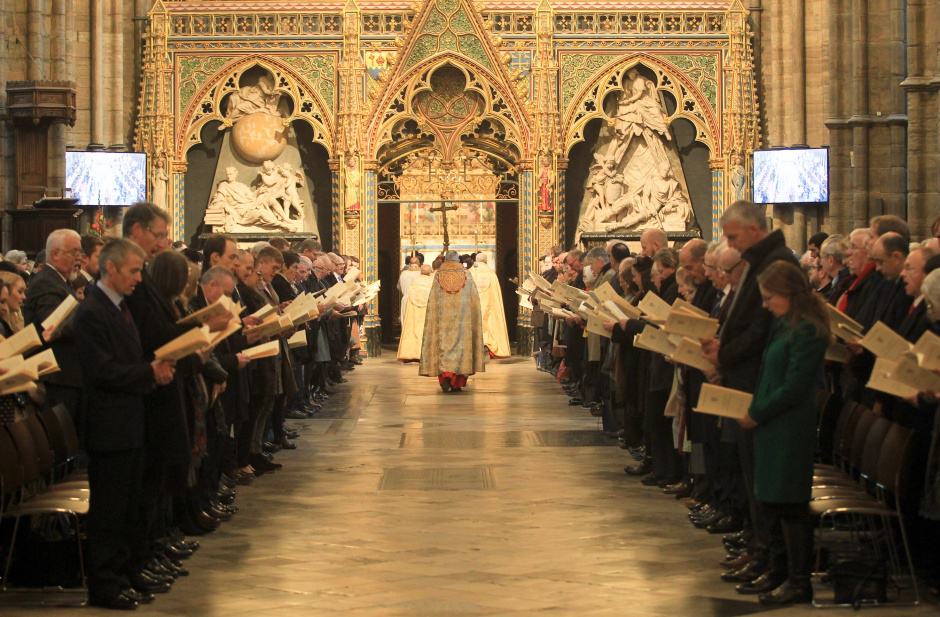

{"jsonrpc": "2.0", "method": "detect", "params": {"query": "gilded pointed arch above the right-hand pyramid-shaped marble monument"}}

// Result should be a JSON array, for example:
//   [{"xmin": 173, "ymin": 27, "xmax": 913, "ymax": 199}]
[{"xmin": 562, "ymin": 54, "xmax": 722, "ymax": 155}]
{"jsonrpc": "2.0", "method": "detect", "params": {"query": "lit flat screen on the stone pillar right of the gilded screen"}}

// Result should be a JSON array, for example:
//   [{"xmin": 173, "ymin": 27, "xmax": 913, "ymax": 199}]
[{"xmin": 752, "ymin": 148, "xmax": 829, "ymax": 204}]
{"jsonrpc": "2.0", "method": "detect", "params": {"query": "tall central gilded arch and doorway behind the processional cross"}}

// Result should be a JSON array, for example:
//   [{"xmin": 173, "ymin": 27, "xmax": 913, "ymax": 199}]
[{"xmin": 376, "ymin": 59, "xmax": 521, "ymax": 344}]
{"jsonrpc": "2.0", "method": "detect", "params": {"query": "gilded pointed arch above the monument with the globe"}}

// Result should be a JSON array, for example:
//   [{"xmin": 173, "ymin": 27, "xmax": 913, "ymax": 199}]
[{"xmin": 174, "ymin": 55, "xmax": 334, "ymax": 159}]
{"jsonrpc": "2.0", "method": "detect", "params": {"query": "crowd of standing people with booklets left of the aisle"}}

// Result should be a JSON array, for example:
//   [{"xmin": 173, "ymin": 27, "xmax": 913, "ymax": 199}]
[{"xmin": 0, "ymin": 203, "xmax": 364, "ymax": 610}]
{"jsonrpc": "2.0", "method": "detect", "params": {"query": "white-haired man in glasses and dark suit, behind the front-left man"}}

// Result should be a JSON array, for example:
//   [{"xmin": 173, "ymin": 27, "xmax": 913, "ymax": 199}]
[{"xmin": 23, "ymin": 229, "xmax": 82, "ymax": 426}]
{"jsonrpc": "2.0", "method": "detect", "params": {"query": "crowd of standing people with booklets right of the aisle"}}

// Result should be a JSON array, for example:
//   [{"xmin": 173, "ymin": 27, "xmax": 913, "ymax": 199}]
[{"xmin": 532, "ymin": 202, "xmax": 940, "ymax": 605}]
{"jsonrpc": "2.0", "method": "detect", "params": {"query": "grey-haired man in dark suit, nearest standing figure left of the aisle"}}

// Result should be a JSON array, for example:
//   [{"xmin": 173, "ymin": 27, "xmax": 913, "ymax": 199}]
[{"xmin": 74, "ymin": 239, "xmax": 173, "ymax": 609}]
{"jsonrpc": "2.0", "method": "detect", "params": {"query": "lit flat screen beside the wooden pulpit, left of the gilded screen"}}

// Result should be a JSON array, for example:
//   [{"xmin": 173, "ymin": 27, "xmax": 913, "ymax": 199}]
[{"xmin": 65, "ymin": 152, "xmax": 147, "ymax": 206}]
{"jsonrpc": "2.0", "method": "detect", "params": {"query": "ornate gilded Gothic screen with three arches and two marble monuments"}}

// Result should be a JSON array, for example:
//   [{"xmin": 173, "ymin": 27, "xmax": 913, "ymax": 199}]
[{"xmin": 135, "ymin": 0, "xmax": 759, "ymax": 348}]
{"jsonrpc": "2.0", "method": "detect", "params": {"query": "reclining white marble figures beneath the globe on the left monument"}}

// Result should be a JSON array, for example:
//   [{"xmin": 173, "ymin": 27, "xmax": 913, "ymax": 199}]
[{"xmin": 205, "ymin": 161, "xmax": 304, "ymax": 233}]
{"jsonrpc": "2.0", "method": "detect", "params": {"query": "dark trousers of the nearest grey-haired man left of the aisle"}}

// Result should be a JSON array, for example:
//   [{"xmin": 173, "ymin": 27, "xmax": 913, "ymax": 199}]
[{"xmin": 87, "ymin": 448, "xmax": 143, "ymax": 597}]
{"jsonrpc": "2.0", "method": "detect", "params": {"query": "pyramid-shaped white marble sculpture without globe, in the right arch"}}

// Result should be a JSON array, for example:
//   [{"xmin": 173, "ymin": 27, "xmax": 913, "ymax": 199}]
[{"xmin": 575, "ymin": 69, "xmax": 694, "ymax": 242}]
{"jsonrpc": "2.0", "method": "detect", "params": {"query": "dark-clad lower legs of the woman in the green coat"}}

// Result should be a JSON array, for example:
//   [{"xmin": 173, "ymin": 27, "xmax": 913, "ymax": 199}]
[{"xmin": 758, "ymin": 501, "xmax": 813, "ymax": 584}]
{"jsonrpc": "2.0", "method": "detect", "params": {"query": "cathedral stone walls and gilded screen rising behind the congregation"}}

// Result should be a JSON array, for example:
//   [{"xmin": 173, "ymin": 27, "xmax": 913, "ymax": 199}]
[{"xmin": 0, "ymin": 0, "xmax": 940, "ymax": 346}]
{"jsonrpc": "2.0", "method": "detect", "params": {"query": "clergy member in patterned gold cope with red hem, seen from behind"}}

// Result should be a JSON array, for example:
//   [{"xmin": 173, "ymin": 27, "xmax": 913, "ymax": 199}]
[{"xmin": 418, "ymin": 251, "xmax": 483, "ymax": 392}]
